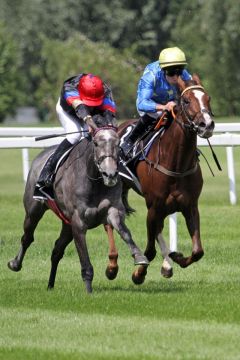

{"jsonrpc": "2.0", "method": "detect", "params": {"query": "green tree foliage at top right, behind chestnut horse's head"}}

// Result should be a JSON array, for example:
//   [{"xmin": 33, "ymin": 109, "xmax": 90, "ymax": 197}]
[{"xmin": 166, "ymin": 0, "xmax": 240, "ymax": 116}]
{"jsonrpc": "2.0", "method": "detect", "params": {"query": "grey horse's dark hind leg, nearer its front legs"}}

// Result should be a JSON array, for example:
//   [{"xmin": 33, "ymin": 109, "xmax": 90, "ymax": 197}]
[{"xmin": 48, "ymin": 222, "xmax": 73, "ymax": 289}]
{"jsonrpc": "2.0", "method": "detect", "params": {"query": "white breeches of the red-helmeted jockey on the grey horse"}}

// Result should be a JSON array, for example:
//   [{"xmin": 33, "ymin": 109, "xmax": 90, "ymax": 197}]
[{"xmin": 56, "ymin": 99, "xmax": 88, "ymax": 144}]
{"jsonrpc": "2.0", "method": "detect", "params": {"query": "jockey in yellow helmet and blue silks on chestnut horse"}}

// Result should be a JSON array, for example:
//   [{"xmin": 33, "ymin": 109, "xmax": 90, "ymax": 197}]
[{"xmin": 121, "ymin": 47, "xmax": 191, "ymax": 158}]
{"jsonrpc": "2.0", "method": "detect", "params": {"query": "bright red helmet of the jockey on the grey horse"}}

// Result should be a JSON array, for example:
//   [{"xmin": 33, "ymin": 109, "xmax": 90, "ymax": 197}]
[{"xmin": 78, "ymin": 74, "xmax": 104, "ymax": 106}]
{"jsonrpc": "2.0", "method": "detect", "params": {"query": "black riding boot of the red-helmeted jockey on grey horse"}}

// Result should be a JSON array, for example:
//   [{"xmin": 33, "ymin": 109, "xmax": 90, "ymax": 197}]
[{"xmin": 36, "ymin": 139, "xmax": 72, "ymax": 187}]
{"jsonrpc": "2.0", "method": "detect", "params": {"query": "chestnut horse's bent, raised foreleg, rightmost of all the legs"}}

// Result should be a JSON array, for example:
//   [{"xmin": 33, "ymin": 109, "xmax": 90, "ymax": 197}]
[{"xmin": 169, "ymin": 206, "xmax": 204, "ymax": 268}]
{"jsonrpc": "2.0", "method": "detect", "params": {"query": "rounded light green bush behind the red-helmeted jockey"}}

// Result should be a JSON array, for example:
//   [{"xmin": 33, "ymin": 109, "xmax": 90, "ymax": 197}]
[{"xmin": 35, "ymin": 33, "xmax": 142, "ymax": 119}]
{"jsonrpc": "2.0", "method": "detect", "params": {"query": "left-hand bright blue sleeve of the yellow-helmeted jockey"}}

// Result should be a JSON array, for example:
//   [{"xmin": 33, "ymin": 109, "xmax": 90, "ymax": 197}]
[{"xmin": 137, "ymin": 69, "xmax": 156, "ymax": 112}]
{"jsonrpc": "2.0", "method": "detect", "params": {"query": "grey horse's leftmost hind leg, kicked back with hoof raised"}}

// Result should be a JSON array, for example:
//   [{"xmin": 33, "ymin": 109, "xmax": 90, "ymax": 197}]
[{"xmin": 8, "ymin": 200, "xmax": 47, "ymax": 271}]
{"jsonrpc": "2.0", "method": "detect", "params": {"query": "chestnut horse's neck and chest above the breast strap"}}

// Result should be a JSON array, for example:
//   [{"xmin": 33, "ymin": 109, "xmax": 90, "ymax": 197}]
[{"xmin": 160, "ymin": 121, "xmax": 197, "ymax": 172}]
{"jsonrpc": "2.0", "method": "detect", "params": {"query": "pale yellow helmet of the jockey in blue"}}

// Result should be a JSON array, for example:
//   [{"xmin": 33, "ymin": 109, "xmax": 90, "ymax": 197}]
[{"xmin": 159, "ymin": 47, "xmax": 187, "ymax": 69}]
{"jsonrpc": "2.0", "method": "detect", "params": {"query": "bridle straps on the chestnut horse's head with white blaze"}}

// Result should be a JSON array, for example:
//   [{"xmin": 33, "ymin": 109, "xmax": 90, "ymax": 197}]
[{"xmin": 177, "ymin": 85, "xmax": 212, "ymax": 133}]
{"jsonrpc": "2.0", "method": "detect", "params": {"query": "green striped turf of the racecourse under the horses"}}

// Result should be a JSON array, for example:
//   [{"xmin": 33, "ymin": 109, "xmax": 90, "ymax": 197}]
[{"xmin": 0, "ymin": 144, "xmax": 240, "ymax": 360}]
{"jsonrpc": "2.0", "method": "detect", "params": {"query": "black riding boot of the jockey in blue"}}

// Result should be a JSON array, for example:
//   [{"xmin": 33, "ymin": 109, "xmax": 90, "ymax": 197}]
[{"xmin": 121, "ymin": 115, "xmax": 156, "ymax": 158}]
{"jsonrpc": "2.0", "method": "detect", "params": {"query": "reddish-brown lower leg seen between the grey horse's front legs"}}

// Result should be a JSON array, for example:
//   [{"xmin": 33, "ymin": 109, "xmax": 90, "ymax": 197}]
[{"xmin": 104, "ymin": 225, "xmax": 118, "ymax": 280}]
